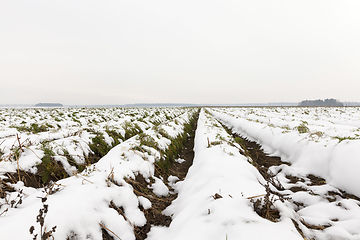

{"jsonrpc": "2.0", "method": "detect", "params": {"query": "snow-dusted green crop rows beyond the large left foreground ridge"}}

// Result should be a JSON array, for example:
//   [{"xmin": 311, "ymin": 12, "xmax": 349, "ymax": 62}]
[{"xmin": 0, "ymin": 108, "xmax": 186, "ymax": 176}]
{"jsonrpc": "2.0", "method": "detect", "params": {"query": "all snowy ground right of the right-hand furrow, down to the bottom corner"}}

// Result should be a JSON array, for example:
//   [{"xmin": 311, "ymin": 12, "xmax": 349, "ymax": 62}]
[{"xmin": 211, "ymin": 107, "xmax": 360, "ymax": 239}]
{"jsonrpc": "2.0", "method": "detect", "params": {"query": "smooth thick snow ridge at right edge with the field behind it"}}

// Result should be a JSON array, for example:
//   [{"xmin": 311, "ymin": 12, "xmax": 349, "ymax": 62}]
[{"xmin": 208, "ymin": 107, "xmax": 360, "ymax": 197}]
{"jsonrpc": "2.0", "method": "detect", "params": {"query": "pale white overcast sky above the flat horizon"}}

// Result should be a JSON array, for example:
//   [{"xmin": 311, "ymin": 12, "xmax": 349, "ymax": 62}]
[{"xmin": 0, "ymin": 0, "xmax": 360, "ymax": 104}]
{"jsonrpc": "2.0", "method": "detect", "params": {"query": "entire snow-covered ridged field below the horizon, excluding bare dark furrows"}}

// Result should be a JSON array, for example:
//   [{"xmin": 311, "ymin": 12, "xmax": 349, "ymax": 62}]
[{"xmin": 0, "ymin": 107, "xmax": 360, "ymax": 240}]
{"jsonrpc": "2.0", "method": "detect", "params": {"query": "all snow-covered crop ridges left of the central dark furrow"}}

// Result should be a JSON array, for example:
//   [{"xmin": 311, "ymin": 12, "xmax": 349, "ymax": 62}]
[{"xmin": 0, "ymin": 108, "xmax": 196, "ymax": 239}]
